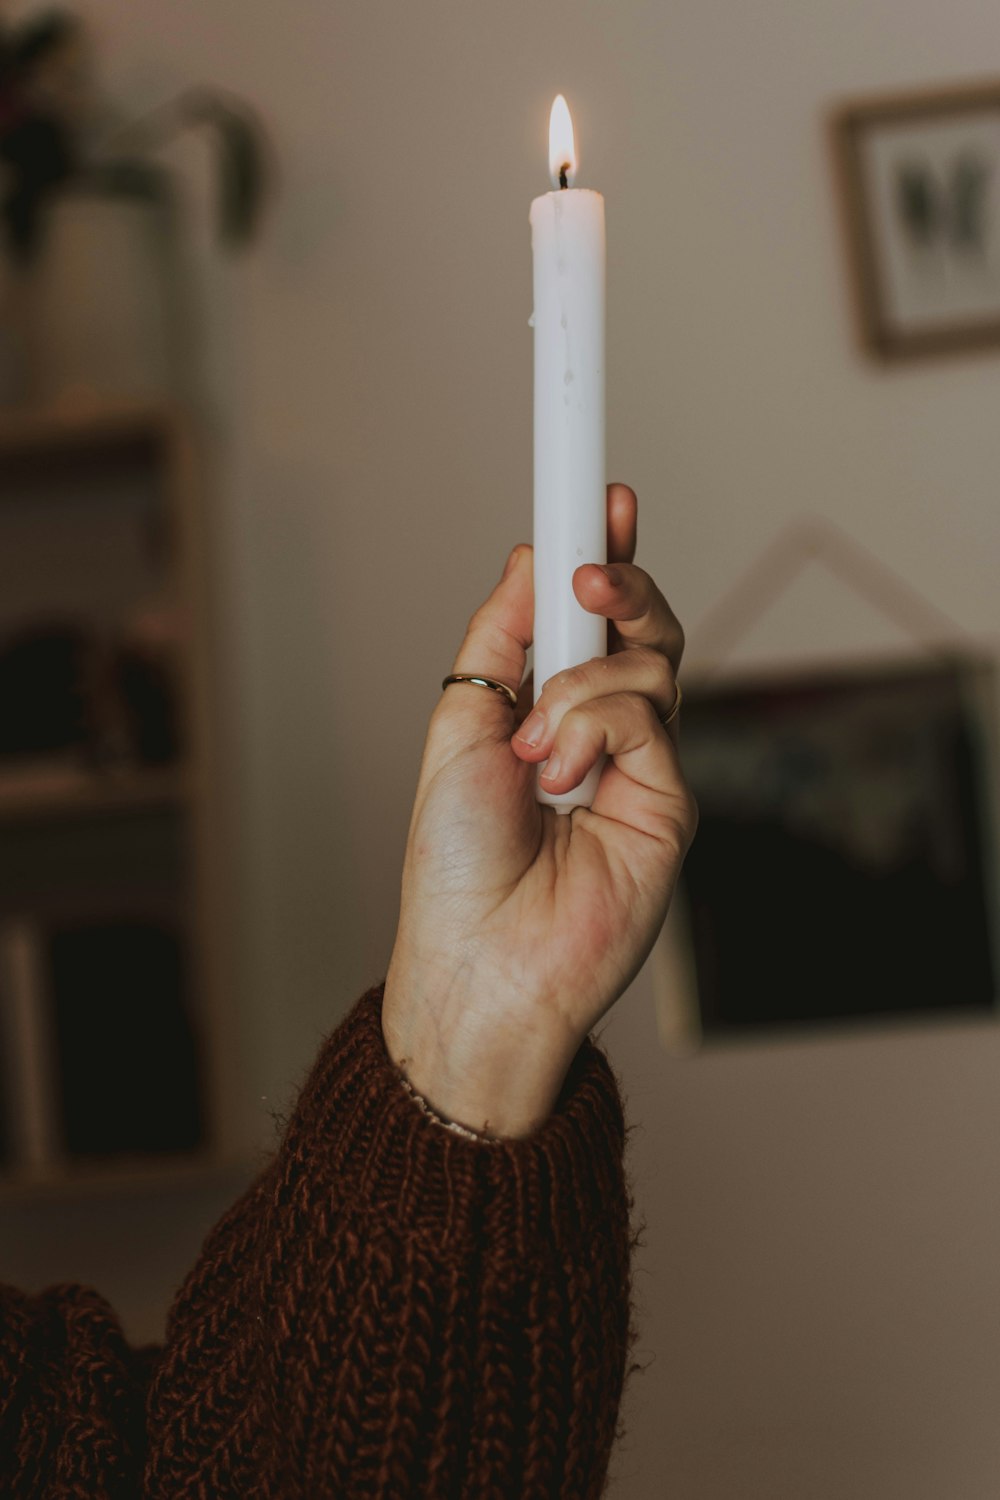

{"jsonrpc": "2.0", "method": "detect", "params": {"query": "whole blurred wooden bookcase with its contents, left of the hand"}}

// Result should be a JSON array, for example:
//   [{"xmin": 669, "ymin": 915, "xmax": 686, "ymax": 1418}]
[{"xmin": 0, "ymin": 401, "xmax": 247, "ymax": 1203}]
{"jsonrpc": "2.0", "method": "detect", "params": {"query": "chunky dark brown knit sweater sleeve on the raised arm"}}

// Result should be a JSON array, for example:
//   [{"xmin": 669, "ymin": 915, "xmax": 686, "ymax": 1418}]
[{"xmin": 0, "ymin": 986, "xmax": 633, "ymax": 1500}]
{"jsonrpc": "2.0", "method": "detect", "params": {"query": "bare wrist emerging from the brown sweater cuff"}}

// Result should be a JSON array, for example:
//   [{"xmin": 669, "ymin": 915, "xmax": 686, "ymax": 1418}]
[{"xmin": 382, "ymin": 966, "xmax": 580, "ymax": 1139}]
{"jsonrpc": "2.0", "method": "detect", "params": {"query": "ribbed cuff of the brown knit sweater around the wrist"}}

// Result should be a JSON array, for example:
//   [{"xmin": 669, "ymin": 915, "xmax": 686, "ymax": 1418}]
[{"xmin": 283, "ymin": 984, "xmax": 625, "ymax": 1256}]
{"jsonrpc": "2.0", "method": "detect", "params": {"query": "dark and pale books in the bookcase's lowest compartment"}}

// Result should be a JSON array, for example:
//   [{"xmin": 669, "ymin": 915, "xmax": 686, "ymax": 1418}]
[{"xmin": 0, "ymin": 914, "xmax": 205, "ymax": 1173}]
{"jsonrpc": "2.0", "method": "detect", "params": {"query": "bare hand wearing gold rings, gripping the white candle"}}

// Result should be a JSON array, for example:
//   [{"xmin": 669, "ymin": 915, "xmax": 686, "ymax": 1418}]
[{"xmin": 382, "ymin": 485, "xmax": 697, "ymax": 1136}]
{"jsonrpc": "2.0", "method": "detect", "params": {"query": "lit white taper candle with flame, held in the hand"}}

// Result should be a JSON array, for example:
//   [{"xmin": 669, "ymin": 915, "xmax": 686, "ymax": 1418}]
[{"xmin": 531, "ymin": 95, "xmax": 607, "ymax": 813}]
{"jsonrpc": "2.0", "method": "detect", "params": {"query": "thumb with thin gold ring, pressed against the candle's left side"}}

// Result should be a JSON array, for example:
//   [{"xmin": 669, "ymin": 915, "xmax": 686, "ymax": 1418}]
[{"xmin": 439, "ymin": 542, "xmax": 535, "ymax": 735}]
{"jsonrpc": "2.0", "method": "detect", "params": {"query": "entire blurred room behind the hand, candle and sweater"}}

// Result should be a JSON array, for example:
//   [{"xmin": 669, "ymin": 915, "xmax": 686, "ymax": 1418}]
[{"xmin": 0, "ymin": 0, "xmax": 1000, "ymax": 1500}]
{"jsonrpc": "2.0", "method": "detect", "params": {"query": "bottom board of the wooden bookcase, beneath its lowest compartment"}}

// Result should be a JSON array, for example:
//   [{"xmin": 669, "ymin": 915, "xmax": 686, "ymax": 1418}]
[{"xmin": 0, "ymin": 1152, "xmax": 262, "ymax": 1205}]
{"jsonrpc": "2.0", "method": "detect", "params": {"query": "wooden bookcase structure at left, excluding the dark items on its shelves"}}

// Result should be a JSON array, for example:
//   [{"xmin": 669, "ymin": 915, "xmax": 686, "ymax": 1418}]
[{"xmin": 0, "ymin": 399, "xmax": 245, "ymax": 1206}]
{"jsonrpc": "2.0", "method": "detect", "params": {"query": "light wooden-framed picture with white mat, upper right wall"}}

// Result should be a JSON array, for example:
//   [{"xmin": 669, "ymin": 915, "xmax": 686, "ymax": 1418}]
[{"xmin": 834, "ymin": 81, "xmax": 1000, "ymax": 359}]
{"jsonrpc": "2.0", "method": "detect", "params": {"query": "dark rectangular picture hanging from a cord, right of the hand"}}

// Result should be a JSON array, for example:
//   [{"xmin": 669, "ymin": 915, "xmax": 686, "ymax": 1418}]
[{"xmin": 671, "ymin": 657, "xmax": 997, "ymax": 1041}]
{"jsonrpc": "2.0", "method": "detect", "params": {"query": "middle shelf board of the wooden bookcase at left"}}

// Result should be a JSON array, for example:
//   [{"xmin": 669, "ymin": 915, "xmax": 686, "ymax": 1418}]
[{"xmin": 0, "ymin": 765, "xmax": 192, "ymax": 825}]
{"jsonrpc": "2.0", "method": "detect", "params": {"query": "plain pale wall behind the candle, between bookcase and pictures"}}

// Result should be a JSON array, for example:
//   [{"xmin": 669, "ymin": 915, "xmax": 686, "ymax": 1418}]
[{"xmin": 15, "ymin": 0, "xmax": 1000, "ymax": 1500}]
